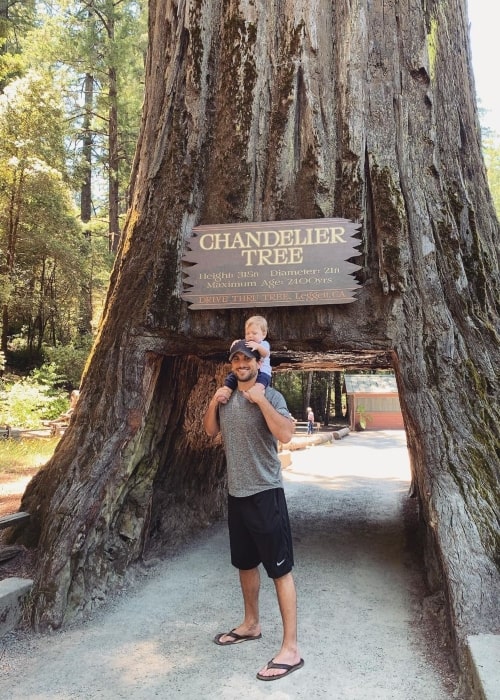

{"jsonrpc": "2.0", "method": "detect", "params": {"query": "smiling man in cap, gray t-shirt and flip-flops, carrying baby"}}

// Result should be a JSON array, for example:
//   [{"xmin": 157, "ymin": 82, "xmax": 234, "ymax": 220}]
[{"xmin": 203, "ymin": 340, "xmax": 304, "ymax": 681}]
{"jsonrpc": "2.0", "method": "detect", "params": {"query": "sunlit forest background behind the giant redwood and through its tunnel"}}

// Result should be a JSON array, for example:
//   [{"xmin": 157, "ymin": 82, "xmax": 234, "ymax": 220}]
[{"xmin": 0, "ymin": 0, "xmax": 500, "ymax": 428}]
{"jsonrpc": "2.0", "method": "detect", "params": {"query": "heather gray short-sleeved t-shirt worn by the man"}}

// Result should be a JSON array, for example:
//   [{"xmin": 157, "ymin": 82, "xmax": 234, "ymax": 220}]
[{"xmin": 219, "ymin": 387, "xmax": 291, "ymax": 498}]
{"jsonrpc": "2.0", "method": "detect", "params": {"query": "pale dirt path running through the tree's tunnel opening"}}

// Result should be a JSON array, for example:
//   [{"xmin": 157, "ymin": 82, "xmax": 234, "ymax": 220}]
[{"xmin": 0, "ymin": 431, "xmax": 459, "ymax": 700}]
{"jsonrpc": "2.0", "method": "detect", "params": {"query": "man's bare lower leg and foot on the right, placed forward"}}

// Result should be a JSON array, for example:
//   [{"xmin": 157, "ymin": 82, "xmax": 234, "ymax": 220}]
[{"xmin": 260, "ymin": 572, "xmax": 300, "ymax": 676}]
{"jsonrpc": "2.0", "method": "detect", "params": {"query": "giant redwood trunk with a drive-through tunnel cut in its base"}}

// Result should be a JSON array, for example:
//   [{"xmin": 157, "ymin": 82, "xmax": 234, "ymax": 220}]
[{"xmin": 15, "ymin": 0, "xmax": 500, "ymax": 680}]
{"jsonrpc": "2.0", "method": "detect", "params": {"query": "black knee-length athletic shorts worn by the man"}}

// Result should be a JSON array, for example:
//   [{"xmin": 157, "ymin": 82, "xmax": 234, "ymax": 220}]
[{"xmin": 228, "ymin": 488, "xmax": 293, "ymax": 578}]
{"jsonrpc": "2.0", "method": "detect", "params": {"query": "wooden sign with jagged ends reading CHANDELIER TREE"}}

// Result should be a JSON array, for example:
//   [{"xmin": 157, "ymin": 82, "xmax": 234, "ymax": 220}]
[{"xmin": 182, "ymin": 219, "xmax": 361, "ymax": 309}]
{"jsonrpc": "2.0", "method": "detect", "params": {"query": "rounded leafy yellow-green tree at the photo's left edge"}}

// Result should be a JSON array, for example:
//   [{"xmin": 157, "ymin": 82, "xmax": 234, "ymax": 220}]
[{"xmin": 0, "ymin": 72, "xmax": 80, "ymax": 352}]
